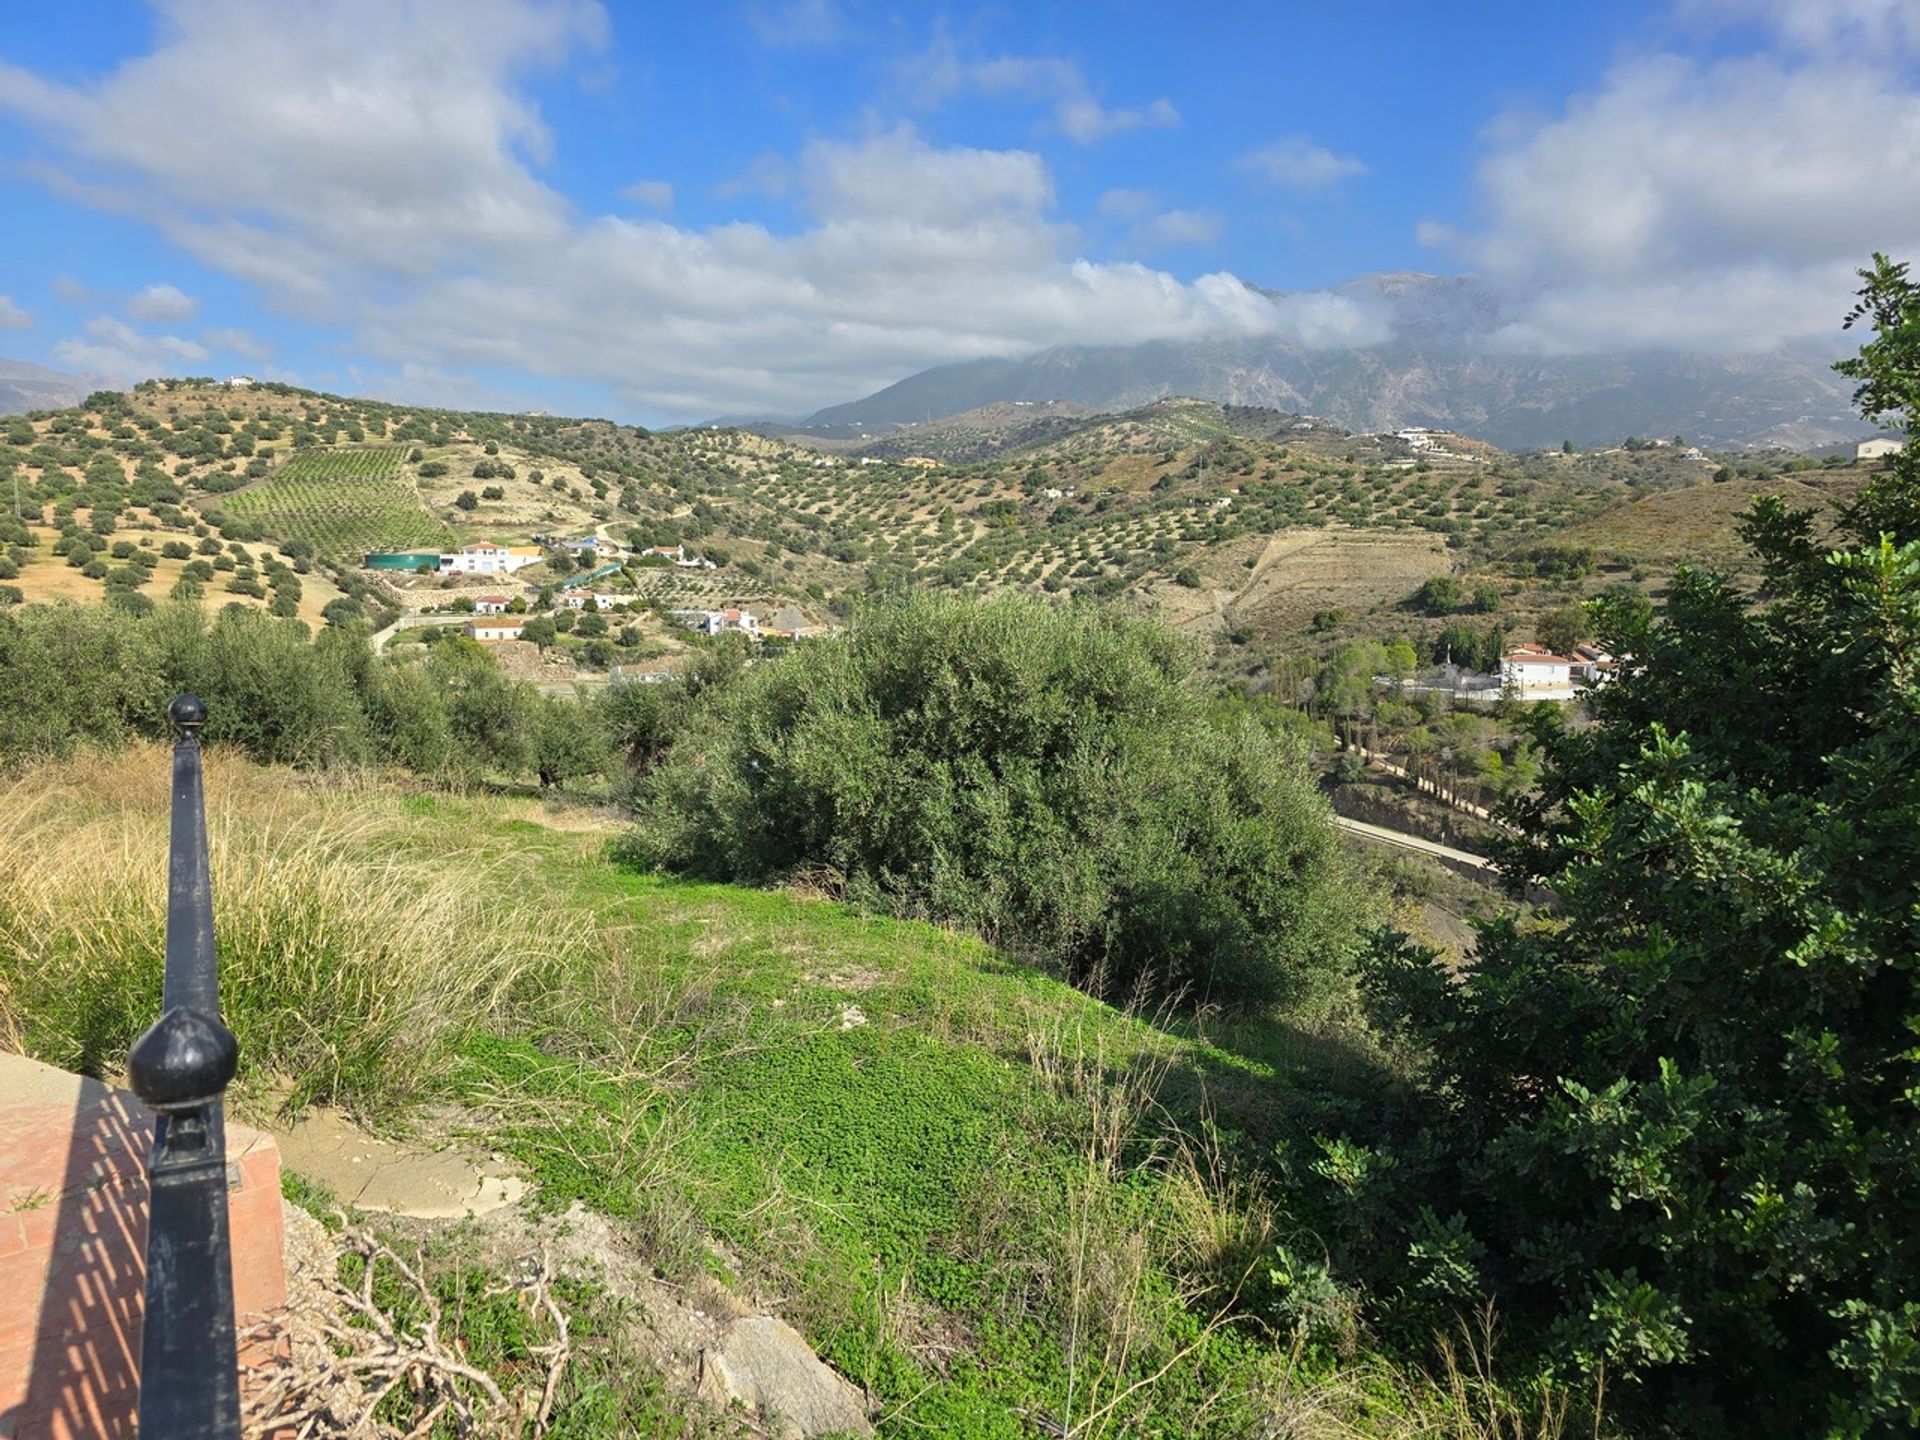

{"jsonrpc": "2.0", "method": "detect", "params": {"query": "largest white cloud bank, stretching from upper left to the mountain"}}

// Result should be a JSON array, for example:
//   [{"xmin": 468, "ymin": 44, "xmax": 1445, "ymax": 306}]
[{"xmin": 0, "ymin": 0, "xmax": 1380, "ymax": 419}]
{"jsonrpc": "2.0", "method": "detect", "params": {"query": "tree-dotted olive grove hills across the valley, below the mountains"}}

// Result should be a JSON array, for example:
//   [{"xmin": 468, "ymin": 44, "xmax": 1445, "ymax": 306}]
[{"xmin": 0, "ymin": 382, "xmax": 1862, "ymax": 684}]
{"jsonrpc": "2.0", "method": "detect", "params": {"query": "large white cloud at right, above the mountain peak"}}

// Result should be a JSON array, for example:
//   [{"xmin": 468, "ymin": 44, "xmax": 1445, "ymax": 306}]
[{"xmin": 1457, "ymin": 41, "xmax": 1920, "ymax": 349}]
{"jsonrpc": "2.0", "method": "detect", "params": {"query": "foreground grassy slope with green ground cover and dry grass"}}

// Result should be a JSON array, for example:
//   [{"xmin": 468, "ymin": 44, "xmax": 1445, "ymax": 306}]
[{"xmin": 0, "ymin": 747, "xmax": 1543, "ymax": 1440}]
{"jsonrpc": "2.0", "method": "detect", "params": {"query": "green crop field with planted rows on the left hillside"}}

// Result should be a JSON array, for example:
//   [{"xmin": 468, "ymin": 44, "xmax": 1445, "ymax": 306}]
[{"xmin": 225, "ymin": 445, "xmax": 451, "ymax": 559}]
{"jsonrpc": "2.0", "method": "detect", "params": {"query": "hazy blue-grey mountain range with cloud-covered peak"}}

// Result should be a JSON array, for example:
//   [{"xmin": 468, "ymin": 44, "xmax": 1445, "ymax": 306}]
[{"xmin": 795, "ymin": 273, "xmax": 1874, "ymax": 449}]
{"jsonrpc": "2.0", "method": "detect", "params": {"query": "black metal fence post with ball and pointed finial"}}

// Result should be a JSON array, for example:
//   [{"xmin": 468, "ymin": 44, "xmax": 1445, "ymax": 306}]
[{"xmin": 127, "ymin": 695, "xmax": 240, "ymax": 1440}]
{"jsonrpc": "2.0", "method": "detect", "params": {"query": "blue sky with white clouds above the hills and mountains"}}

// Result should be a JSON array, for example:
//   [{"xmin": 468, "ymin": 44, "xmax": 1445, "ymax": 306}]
[{"xmin": 0, "ymin": 0, "xmax": 1920, "ymax": 422}]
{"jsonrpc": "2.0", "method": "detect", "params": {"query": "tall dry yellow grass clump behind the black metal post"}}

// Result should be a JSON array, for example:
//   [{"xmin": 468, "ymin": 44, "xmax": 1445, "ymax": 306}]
[{"xmin": 0, "ymin": 747, "xmax": 595, "ymax": 1114}]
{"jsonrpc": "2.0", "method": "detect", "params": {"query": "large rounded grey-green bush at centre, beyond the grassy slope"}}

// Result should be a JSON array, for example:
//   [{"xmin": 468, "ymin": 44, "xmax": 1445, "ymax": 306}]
[{"xmin": 630, "ymin": 595, "xmax": 1357, "ymax": 1006}]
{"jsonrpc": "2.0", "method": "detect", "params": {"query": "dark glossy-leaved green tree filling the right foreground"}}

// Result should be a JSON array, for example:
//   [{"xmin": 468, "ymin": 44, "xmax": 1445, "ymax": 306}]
[{"xmin": 1359, "ymin": 259, "xmax": 1920, "ymax": 1440}]
